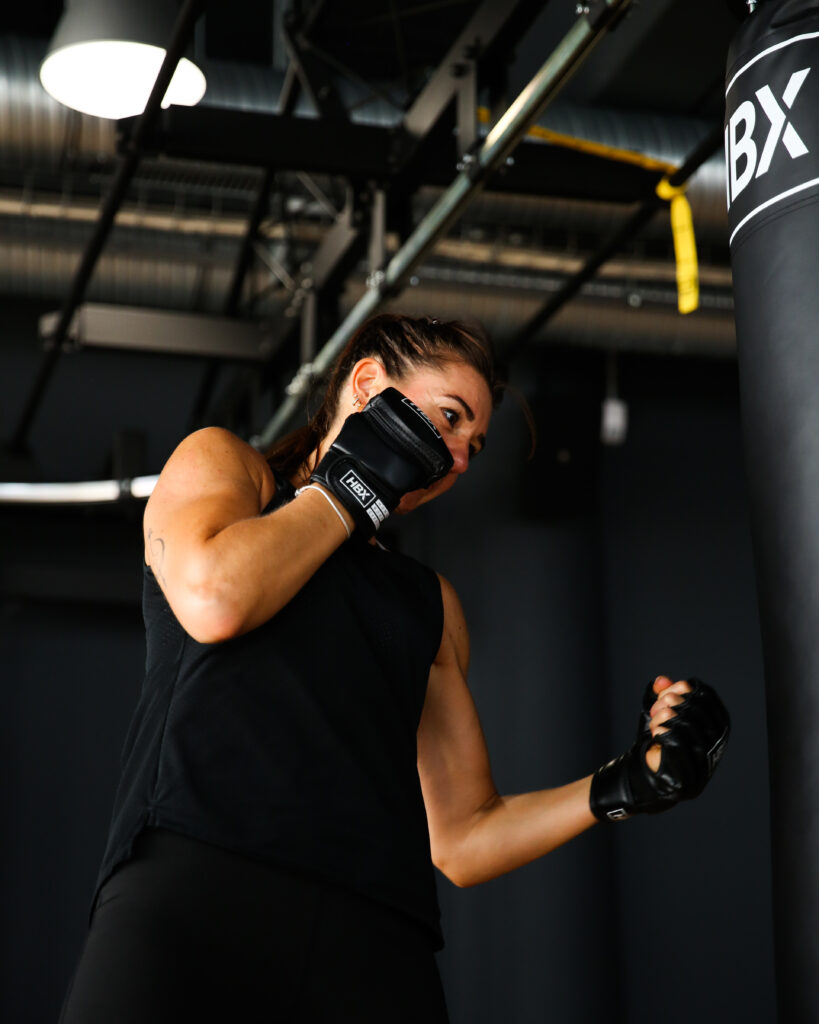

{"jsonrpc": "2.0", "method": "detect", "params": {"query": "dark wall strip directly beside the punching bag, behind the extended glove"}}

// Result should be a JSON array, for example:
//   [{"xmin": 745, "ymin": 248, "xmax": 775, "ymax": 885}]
[{"xmin": 603, "ymin": 361, "xmax": 776, "ymax": 1024}]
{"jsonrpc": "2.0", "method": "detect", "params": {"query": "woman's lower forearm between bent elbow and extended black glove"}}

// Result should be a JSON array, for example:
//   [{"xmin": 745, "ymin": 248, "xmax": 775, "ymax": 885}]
[{"xmin": 439, "ymin": 775, "xmax": 595, "ymax": 886}]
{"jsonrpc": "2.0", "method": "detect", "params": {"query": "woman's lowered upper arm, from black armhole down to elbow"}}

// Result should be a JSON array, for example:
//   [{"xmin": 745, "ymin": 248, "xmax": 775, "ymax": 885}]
[{"xmin": 418, "ymin": 577, "xmax": 497, "ymax": 872}]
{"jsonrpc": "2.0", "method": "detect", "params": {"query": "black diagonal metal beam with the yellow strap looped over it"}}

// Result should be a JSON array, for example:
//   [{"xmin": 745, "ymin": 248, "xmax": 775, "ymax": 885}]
[{"xmin": 503, "ymin": 127, "xmax": 723, "ymax": 361}]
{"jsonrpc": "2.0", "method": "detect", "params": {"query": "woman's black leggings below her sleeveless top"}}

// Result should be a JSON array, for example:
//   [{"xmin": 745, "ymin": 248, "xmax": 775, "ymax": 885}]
[{"xmin": 60, "ymin": 828, "xmax": 447, "ymax": 1024}]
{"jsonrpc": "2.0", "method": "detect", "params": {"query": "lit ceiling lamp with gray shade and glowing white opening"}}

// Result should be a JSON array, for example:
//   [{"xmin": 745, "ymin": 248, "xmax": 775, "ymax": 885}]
[{"xmin": 40, "ymin": 0, "xmax": 206, "ymax": 119}]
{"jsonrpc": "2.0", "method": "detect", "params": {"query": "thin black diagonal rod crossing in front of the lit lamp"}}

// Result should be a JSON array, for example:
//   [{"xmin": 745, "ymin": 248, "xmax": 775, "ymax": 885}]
[{"xmin": 10, "ymin": 0, "xmax": 204, "ymax": 453}]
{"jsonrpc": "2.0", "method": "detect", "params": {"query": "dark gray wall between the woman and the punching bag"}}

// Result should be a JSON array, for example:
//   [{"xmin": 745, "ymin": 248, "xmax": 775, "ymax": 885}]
[{"xmin": 407, "ymin": 353, "xmax": 776, "ymax": 1024}]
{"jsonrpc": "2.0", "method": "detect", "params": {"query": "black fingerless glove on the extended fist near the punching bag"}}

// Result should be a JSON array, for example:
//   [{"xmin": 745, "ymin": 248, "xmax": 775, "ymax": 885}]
[{"xmin": 590, "ymin": 679, "xmax": 731, "ymax": 821}]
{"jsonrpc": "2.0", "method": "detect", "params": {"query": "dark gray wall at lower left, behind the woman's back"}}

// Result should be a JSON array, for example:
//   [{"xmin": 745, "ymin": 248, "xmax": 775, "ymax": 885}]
[{"xmin": 0, "ymin": 598, "xmax": 144, "ymax": 1024}]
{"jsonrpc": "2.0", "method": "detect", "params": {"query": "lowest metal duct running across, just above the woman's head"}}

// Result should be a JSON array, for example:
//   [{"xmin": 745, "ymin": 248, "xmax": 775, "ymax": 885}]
[{"xmin": 0, "ymin": 210, "xmax": 734, "ymax": 356}]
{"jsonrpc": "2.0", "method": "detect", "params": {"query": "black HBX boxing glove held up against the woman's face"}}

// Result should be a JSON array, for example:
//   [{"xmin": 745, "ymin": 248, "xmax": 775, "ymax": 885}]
[{"xmin": 311, "ymin": 387, "xmax": 452, "ymax": 537}]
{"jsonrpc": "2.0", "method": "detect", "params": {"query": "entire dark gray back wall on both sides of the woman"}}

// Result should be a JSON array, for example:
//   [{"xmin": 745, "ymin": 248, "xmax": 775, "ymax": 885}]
[{"xmin": 0, "ymin": 317, "xmax": 775, "ymax": 1024}]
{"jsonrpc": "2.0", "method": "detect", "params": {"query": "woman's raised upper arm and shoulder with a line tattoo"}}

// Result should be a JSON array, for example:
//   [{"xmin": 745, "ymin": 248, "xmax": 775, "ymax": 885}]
[{"xmin": 143, "ymin": 427, "xmax": 274, "ymax": 621}]
